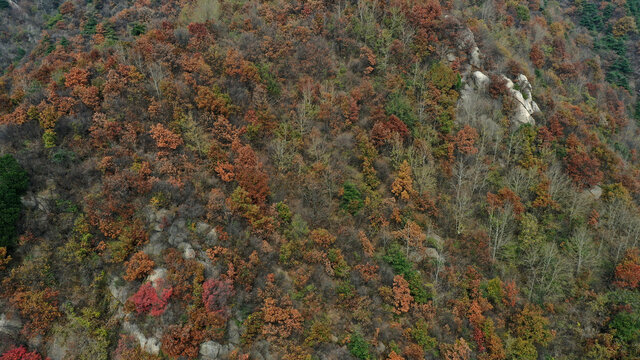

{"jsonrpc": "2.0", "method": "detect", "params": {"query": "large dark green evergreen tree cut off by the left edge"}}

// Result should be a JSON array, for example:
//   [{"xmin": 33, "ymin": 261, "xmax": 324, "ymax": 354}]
[{"xmin": 0, "ymin": 154, "xmax": 29, "ymax": 247}]
